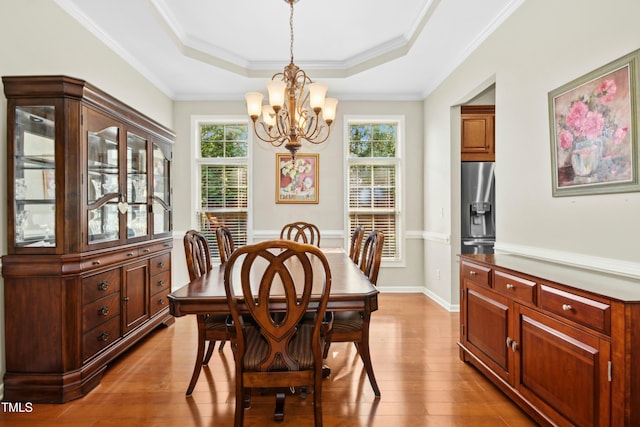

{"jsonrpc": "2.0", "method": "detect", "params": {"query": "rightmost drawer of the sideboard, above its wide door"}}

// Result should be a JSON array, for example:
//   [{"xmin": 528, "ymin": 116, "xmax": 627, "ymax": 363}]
[{"xmin": 540, "ymin": 285, "xmax": 611, "ymax": 334}]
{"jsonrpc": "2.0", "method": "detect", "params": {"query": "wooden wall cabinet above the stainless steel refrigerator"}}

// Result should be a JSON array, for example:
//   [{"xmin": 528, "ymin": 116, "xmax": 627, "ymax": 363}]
[{"xmin": 460, "ymin": 105, "xmax": 495, "ymax": 162}]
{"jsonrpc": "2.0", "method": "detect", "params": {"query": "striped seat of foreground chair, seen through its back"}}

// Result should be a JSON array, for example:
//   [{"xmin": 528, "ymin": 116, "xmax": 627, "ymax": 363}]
[{"xmin": 243, "ymin": 324, "xmax": 313, "ymax": 371}]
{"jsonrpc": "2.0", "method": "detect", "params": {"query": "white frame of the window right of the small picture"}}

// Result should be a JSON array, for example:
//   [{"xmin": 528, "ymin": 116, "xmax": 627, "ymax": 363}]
[{"xmin": 343, "ymin": 115, "xmax": 406, "ymax": 267}]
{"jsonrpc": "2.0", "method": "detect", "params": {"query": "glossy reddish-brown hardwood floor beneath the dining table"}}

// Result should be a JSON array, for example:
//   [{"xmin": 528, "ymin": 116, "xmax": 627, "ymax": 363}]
[{"xmin": 0, "ymin": 294, "xmax": 535, "ymax": 427}]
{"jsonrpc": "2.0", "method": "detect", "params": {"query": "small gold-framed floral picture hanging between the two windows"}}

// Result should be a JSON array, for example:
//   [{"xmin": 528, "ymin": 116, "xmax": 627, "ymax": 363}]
[{"xmin": 276, "ymin": 153, "xmax": 320, "ymax": 203}]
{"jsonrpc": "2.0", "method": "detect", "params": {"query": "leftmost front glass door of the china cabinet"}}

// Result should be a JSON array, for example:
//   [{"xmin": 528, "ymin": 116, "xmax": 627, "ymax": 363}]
[{"xmin": 87, "ymin": 115, "xmax": 121, "ymax": 244}]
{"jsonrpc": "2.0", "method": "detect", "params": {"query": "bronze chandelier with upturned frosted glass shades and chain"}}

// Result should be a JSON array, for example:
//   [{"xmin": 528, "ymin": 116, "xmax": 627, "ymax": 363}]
[{"xmin": 245, "ymin": 0, "xmax": 338, "ymax": 160}]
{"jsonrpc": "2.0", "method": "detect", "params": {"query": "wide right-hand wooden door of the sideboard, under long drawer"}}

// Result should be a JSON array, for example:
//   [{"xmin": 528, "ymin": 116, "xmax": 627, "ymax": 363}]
[{"xmin": 516, "ymin": 306, "xmax": 610, "ymax": 426}]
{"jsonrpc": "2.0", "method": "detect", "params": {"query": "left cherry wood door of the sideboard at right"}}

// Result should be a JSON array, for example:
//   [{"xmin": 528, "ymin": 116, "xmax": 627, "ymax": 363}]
[{"xmin": 465, "ymin": 284, "xmax": 510, "ymax": 380}]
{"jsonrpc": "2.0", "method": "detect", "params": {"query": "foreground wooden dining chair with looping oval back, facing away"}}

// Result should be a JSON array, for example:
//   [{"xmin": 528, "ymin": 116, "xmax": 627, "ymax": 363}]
[{"xmin": 224, "ymin": 239, "xmax": 331, "ymax": 427}]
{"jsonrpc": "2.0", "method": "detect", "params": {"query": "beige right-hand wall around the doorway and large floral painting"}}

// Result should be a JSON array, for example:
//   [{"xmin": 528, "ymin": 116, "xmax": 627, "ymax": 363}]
[{"xmin": 425, "ymin": 0, "xmax": 640, "ymax": 305}]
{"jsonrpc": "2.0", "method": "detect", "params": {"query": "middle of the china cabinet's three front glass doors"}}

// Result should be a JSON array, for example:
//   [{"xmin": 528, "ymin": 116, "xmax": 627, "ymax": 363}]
[{"xmin": 127, "ymin": 132, "xmax": 148, "ymax": 238}]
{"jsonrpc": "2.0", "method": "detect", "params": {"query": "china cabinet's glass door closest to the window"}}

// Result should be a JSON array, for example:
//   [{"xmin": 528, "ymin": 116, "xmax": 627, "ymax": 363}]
[{"xmin": 152, "ymin": 143, "xmax": 171, "ymax": 235}]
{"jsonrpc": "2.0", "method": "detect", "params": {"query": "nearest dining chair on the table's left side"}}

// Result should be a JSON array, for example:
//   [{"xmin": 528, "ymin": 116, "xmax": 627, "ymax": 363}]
[{"xmin": 183, "ymin": 230, "xmax": 229, "ymax": 396}]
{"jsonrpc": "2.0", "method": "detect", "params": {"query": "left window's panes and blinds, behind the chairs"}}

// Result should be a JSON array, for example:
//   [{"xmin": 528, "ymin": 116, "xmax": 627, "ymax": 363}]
[{"xmin": 196, "ymin": 122, "xmax": 249, "ymax": 258}]
